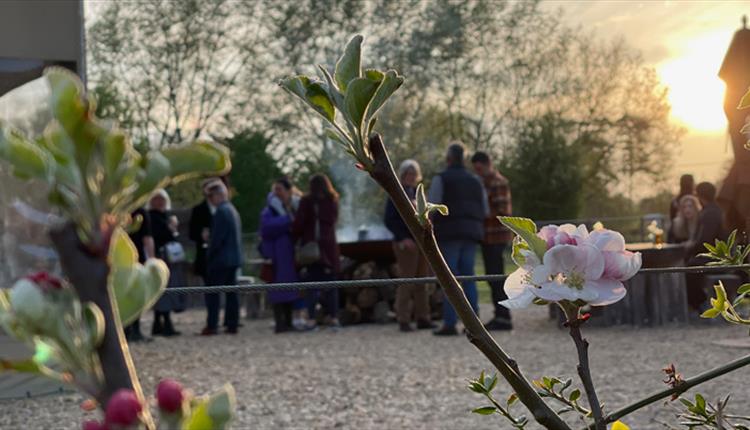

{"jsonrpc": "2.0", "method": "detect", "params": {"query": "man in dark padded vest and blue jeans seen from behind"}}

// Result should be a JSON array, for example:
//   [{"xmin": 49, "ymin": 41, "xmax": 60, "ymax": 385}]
[{"xmin": 428, "ymin": 142, "xmax": 489, "ymax": 336}]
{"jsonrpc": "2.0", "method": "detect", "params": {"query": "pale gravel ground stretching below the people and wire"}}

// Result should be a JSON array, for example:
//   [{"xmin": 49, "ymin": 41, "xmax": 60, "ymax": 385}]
[{"xmin": 0, "ymin": 308, "xmax": 750, "ymax": 430}]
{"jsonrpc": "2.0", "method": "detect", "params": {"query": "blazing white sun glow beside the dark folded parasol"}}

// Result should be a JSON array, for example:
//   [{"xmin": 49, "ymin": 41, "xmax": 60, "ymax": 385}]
[{"xmin": 656, "ymin": 31, "xmax": 732, "ymax": 132}]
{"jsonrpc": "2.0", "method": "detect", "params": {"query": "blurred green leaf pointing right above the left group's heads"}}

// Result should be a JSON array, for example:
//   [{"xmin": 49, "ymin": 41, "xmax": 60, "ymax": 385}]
[{"xmin": 161, "ymin": 140, "xmax": 232, "ymax": 184}]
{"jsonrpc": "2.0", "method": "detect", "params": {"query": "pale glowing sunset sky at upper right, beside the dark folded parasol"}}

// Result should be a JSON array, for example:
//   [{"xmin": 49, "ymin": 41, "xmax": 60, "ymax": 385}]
[{"xmin": 543, "ymin": 0, "xmax": 750, "ymax": 194}]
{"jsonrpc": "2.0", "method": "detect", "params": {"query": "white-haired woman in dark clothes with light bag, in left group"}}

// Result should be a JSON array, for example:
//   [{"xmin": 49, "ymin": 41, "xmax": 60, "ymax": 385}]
[{"xmin": 148, "ymin": 189, "xmax": 185, "ymax": 336}]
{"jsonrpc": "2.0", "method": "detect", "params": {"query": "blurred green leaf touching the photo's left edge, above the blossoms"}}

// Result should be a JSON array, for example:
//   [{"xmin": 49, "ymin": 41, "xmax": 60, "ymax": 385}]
[{"xmin": 0, "ymin": 127, "xmax": 55, "ymax": 181}]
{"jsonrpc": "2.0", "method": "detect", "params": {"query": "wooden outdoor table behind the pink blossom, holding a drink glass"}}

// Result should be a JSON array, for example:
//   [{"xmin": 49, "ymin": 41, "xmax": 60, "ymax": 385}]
[{"xmin": 590, "ymin": 243, "xmax": 688, "ymax": 326}]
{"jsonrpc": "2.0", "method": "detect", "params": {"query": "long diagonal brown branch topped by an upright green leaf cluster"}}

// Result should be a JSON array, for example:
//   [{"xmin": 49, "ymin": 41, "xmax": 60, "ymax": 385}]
[{"xmin": 369, "ymin": 134, "xmax": 570, "ymax": 429}]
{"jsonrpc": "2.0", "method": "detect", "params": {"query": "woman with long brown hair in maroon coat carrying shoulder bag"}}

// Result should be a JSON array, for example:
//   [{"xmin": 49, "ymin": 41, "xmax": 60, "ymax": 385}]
[{"xmin": 292, "ymin": 174, "xmax": 341, "ymax": 328}]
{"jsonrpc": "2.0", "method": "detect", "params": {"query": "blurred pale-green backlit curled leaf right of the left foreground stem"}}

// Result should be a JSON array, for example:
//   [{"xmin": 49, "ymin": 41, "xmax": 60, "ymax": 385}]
[{"xmin": 109, "ymin": 228, "xmax": 169, "ymax": 325}]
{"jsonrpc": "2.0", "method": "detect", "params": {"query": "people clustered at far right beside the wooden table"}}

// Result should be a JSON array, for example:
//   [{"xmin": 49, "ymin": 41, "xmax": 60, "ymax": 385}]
[{"xmin": 667, "ymin": 175, "xmax": 727, "ymax": 311}]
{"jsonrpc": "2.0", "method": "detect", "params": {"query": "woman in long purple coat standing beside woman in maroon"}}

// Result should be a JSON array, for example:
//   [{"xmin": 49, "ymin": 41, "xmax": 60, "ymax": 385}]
[{"xmin": 260, "ymin": 178, "xmax": 309, "ymax": 333}]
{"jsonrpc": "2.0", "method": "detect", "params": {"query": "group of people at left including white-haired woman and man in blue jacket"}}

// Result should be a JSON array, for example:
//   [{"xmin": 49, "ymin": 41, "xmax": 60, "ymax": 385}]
[{"xmin": 125, "ymin": 178, "xmax": 243, "ymax": 342}]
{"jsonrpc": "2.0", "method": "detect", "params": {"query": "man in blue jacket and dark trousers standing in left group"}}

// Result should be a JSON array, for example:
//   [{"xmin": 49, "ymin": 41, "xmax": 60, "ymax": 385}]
[{"xmin": 200, "ymin": 182, "xmax": 243, "ymax": 336}]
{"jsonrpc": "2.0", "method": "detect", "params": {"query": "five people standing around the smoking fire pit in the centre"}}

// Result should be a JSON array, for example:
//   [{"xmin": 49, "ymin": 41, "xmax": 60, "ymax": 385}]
[{"xmin": 260, "ymin": 143, "xmax": 512, "ymax": 336}]
